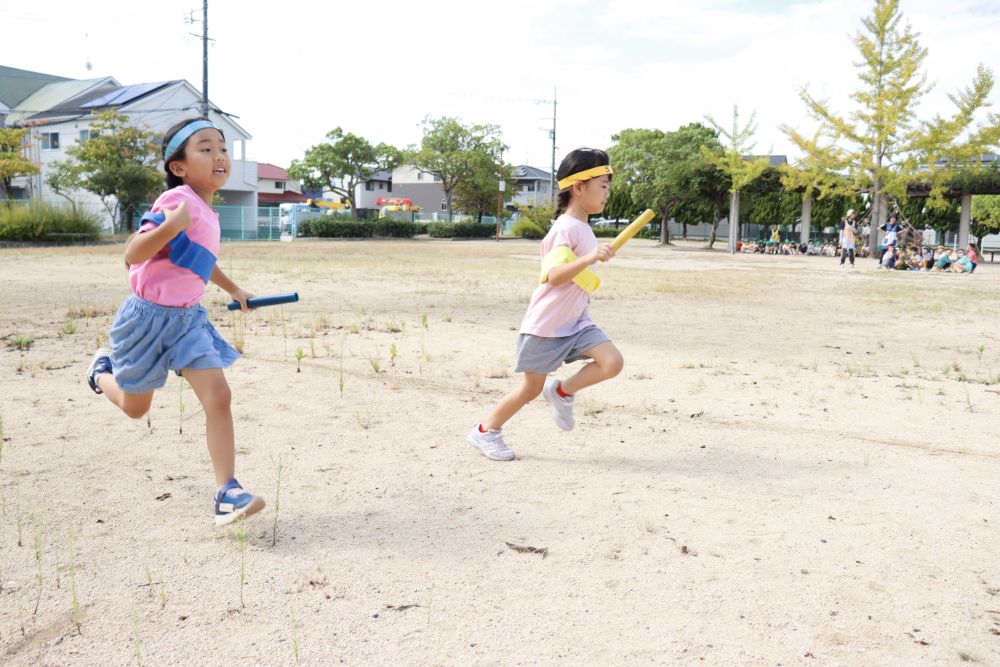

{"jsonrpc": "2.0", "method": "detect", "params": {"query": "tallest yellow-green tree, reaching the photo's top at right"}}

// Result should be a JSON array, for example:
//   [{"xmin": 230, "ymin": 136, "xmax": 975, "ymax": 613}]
[{"xmin": 781, "ymin": 0, "xmax": 1000, "ymax": 256}]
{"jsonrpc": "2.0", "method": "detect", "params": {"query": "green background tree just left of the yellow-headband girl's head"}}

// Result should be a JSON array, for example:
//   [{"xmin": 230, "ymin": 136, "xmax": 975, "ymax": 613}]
[{"xmin": 413, "ymin": 117, "xmax": 507, "ymax": 220}]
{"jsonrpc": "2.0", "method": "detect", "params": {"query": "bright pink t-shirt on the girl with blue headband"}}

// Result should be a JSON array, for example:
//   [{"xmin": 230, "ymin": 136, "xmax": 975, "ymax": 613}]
[{"xmin": 128, "ymin": 185, "xmax": 221, "ymax": 307}]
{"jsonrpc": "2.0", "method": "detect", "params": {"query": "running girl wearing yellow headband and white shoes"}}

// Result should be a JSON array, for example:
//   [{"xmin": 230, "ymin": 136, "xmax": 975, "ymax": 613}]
[{"xmin": 468, "ymin": 148, "xmax": 624, "ymax": 461}]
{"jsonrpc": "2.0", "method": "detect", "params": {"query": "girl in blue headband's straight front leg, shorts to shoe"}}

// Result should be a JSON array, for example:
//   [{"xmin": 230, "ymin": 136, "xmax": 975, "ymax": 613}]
[{"xmin": 181, "ymin": 368, "xmax": 236, "ymax": 486}]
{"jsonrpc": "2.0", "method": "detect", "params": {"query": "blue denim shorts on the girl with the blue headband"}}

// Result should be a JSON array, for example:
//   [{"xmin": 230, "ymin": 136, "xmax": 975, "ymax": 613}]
[{"xmin": 109, "ymin": 294, "xmax": 240, "ymax": 394}]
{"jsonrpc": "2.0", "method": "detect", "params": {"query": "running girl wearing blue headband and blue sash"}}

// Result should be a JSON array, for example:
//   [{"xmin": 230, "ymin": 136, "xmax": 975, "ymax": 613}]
[{"xmin": 87, "ymin": 119, "xmax": 264, "ymax": 526}]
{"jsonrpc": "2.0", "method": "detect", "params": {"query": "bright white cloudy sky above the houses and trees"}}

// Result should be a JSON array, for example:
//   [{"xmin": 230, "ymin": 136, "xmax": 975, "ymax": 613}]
[{"xmin": 0, "ymin": 0, "xmax": 1000, "ymax": 170}]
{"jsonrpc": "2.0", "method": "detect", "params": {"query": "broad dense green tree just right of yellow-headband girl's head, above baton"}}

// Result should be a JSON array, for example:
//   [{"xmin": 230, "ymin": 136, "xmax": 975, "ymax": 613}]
[{"xmin": 608, "ymin": 123, "xmax": 722, "ymax": 245}]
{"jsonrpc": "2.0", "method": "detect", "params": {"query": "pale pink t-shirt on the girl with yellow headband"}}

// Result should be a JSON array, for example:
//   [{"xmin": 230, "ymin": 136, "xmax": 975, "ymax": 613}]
[{"xmin": 521, "ymin": 213, "xmax": 597, "ymax": 338}]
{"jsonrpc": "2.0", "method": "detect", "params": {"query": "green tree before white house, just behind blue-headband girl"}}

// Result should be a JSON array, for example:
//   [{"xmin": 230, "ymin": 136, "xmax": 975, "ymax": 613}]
[{"xmin": 46, "ymin": 109, "xmax": 163, "ymax": 232}]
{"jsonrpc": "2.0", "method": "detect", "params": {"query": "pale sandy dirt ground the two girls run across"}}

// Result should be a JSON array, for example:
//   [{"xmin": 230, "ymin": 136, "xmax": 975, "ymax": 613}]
[{"xmin": 0, "ymin": 240, "xmax": 1000, "ymax": 665}]
